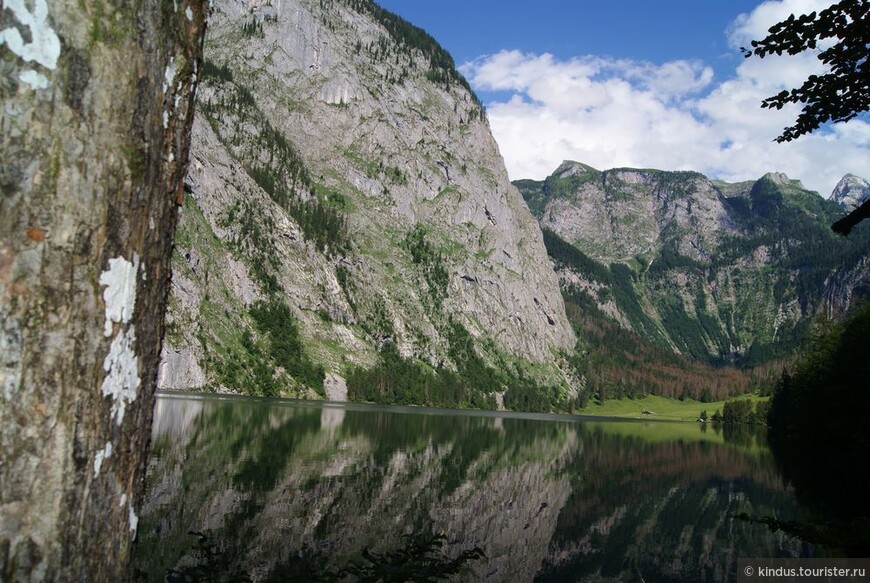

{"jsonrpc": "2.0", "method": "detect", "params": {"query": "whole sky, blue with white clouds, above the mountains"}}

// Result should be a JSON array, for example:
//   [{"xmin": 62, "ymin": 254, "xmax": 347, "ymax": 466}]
[{"xmin": 379, "ymin": 0, "xmax": 870, "ymax": 196}]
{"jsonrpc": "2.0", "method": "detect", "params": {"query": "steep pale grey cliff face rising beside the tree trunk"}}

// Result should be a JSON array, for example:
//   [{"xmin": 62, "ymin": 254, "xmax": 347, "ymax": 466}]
[{"xmin": 161, "ymin": 0, "xmax": 574, "ymax": 396}]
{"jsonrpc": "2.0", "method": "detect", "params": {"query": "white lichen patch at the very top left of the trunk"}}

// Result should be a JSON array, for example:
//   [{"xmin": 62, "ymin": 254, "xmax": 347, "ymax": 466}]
[{"xmin": 0, "ymin": 0, "xmax": 60, "ymax": 89}]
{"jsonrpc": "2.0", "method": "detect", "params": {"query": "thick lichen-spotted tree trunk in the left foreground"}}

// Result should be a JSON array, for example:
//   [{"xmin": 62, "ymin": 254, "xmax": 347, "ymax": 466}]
[{"xmin": 0, "ymin": 0, "xmax": 207, "ymax": 581}]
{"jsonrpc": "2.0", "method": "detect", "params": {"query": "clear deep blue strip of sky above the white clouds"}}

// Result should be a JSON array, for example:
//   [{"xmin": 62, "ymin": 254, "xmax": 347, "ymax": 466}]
[{"xmin": 378, "ymin": 0, "xmax": 758, "ymax": 70}]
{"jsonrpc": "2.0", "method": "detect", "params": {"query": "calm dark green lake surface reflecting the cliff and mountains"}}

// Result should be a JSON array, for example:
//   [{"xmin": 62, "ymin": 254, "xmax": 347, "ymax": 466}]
[{"xmin": 136, "ymin": 394, "xmax": 819, "ymax": 582}]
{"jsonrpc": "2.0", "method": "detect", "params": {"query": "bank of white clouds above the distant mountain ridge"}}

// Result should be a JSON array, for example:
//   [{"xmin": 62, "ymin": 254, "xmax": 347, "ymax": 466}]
[{"xmin": 462, "ymin": 0, "xmax": 870, "ymax": 196}]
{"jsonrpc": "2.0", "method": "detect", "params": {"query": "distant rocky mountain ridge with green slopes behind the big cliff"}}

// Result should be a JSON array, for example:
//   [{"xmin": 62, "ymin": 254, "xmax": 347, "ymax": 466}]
[{"xmin": 515, "ymin": 161, "xmax": 870, "ymax": 364}]
